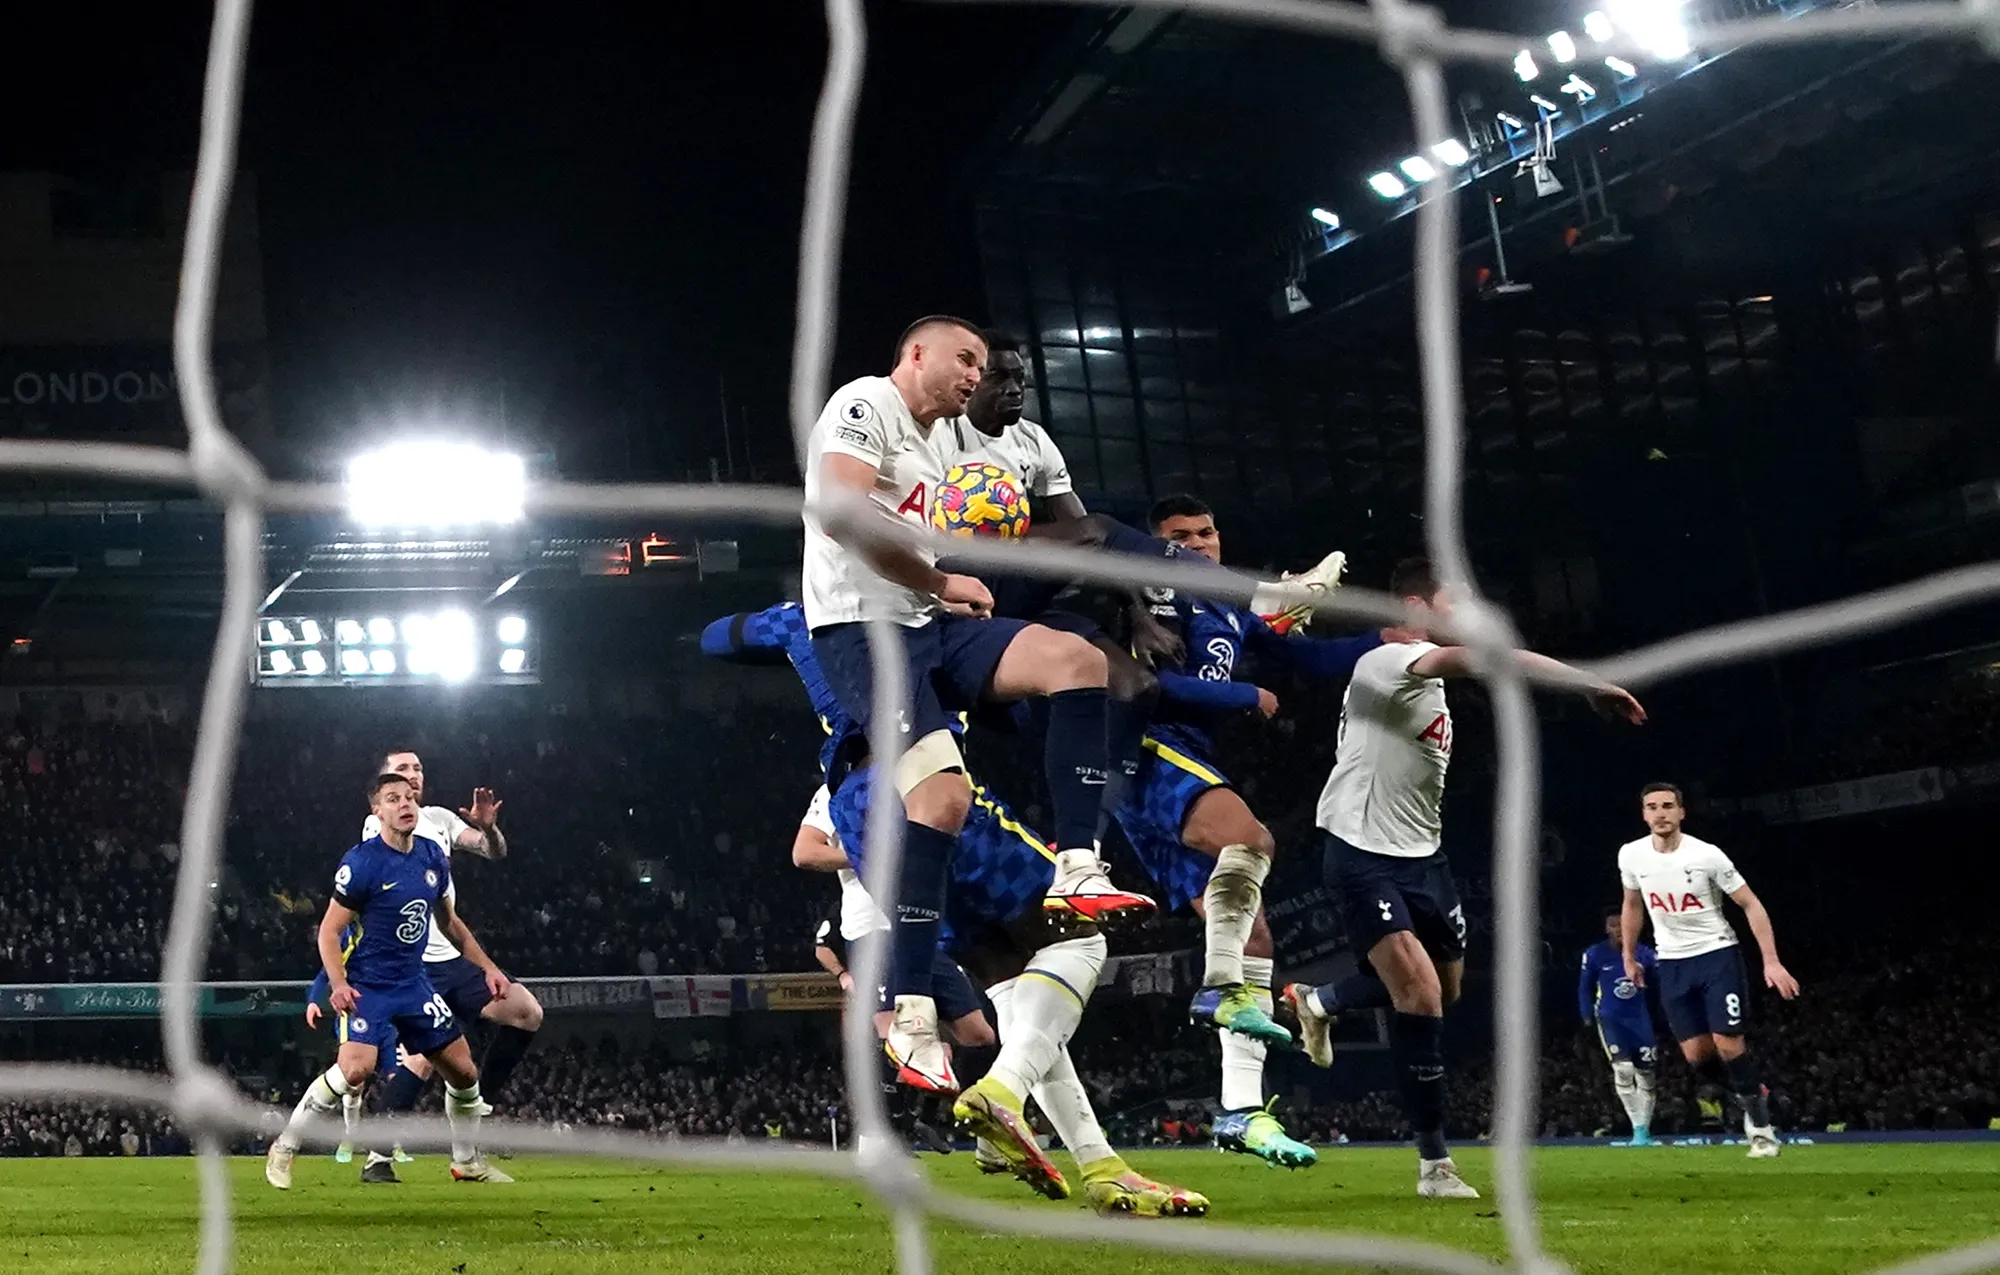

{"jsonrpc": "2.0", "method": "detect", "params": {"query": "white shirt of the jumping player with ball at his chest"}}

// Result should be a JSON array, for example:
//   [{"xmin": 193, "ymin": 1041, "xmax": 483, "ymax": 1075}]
[{"xmin": 804, "ymin": 376, "xmax": 950, "ymax": 630}]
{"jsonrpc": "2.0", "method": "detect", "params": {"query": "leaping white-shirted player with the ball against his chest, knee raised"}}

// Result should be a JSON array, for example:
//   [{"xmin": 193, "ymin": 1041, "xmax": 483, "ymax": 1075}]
[{"xmin": 804, "ymin": 316, "xmax": 1152, "ymax": 1093}]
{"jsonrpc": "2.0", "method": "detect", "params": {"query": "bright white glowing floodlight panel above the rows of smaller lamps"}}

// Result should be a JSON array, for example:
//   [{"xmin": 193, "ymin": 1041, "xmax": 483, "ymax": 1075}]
[{"xmin": 346, "ymin": 442, "xmax": 528, "ymax": 528}]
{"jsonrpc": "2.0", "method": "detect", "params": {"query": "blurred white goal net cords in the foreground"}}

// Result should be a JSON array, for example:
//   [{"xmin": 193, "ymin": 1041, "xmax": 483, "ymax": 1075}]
[{"xmin": 0, "ymin": 0, "xmax": 2000, "ymax": 1275}]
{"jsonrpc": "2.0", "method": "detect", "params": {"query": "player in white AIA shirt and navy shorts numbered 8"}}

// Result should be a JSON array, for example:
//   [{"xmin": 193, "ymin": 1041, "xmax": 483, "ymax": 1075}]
[{"xmin": 1618, "ymin": 783, "xmax": 1798, "ymax": 1159}]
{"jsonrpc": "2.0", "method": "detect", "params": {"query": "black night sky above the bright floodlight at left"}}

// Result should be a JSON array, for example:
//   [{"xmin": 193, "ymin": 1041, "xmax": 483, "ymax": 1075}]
[{"xmin": 0, "ymin": 0, "xmax": 1076, "ymax": 476}]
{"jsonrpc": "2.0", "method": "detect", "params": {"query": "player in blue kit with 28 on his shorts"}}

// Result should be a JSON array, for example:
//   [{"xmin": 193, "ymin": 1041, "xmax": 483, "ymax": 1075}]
[{"xmin": 264, "ymin": 775, "xmax": 512, "ymax": 1191}]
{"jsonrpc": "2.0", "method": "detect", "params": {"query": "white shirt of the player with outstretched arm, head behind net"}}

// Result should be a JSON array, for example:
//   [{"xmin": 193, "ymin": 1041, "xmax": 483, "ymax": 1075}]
[{"xmin": 1318, "ymin": 641, "xmax": 1452, "ymax": 859}]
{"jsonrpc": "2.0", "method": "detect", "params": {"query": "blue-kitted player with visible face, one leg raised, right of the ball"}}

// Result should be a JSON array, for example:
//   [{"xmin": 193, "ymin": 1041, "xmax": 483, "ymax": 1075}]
[{"xmin": 1118, "ymin": 496, "xmax": 1382, "ymax": 1169}]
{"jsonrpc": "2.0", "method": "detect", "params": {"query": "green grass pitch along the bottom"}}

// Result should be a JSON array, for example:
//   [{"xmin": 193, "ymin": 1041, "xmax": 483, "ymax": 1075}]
[{"xmin": 0, "ymin": 1143, "xmax": 2000, "ymax": 1275}]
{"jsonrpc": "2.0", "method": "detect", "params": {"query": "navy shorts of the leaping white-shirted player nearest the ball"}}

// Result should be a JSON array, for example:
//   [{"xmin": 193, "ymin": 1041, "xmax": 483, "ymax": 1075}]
[{"xmin": 812, "ymin": 616, "xmax": 1028, "ymax": 743}]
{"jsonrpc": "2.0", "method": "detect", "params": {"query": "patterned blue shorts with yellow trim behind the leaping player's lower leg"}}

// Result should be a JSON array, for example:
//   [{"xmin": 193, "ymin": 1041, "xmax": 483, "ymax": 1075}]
[{"xmin": 830, "ymin": 765, "xmax": 1056, "ymax": 951}]
